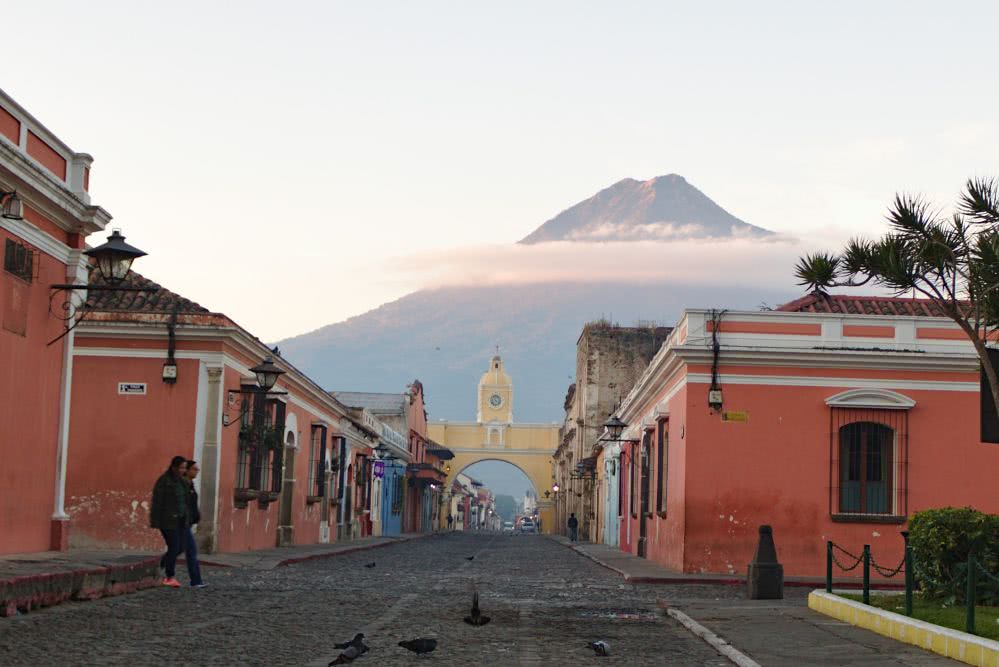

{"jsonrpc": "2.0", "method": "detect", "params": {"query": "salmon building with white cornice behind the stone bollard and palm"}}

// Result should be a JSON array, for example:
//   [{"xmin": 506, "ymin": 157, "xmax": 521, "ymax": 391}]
[{"xmin": 598, "ymin": 296, "xmax": 999, "ymax": 576}]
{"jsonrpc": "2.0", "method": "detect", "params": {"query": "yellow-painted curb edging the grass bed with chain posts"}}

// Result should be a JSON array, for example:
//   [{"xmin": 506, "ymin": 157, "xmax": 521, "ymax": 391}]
[{"xmin": 808, "ymin": 591, "xmax": 999, "ymax": 667}]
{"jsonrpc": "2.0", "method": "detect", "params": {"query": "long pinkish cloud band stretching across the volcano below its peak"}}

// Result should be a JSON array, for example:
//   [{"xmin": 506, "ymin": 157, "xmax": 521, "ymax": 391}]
[{"xmin": 386, "ymin": 236, "xmax": 835, "ymax": 287}]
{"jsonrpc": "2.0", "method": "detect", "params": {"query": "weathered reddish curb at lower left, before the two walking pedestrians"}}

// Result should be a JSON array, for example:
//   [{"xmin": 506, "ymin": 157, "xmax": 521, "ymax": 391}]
[{"xmin": 0, "ymin": 557, "xmax": 159, "ymax": 617}]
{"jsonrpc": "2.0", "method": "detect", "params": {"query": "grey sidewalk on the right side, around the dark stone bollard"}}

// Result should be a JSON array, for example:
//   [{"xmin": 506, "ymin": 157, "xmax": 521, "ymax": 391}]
[{"xmin": 550, "ymin": 536, "xmax": 955, "ymax": 667}]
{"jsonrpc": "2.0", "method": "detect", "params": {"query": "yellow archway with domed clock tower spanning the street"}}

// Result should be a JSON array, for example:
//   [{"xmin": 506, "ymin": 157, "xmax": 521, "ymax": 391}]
[{"xmin": 428, "ymin": 355, "xmax": 559, "ymax": 533}]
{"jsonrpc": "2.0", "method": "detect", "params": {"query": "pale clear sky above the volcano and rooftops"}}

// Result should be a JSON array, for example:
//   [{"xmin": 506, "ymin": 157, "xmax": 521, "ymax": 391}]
[{"xmin": 7, "ymin": 0, "xmax": 999, "ymax": 340}]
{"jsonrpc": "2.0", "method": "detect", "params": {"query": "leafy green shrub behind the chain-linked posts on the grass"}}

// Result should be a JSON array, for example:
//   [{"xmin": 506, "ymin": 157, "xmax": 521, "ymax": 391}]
[{"xmin": 909, "ymin": 507, "xmax": 999, "ymax": 605}]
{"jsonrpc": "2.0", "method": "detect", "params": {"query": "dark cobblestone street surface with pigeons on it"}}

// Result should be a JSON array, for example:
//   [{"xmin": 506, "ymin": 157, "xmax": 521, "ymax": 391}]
[{"xmin": 0, "ymin": 533, "xmax": 742, "ymax": 667}]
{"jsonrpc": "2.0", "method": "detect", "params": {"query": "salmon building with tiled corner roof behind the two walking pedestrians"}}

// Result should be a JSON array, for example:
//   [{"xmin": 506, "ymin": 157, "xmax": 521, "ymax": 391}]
[{"xmin": 66, "ymin": 272, "xmax": 358, "ymax": 552}]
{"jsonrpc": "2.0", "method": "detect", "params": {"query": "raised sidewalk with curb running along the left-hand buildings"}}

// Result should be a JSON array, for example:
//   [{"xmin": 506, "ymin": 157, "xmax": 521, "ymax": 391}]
[{"xmin": 0, "ymin": 533, "xmax": 434, "ymax": 617}]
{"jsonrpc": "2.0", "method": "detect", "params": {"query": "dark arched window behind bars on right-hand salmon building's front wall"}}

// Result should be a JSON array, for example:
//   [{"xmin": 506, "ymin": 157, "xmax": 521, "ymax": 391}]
[{"xmin": 839, "ymin": 421, "xmax": 895, "ymax": 514}]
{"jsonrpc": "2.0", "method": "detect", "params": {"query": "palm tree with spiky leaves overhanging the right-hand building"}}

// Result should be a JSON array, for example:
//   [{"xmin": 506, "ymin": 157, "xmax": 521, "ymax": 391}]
[{"xmin": 794, "ymin": 178, "xmax": 999, "ymax": 413}]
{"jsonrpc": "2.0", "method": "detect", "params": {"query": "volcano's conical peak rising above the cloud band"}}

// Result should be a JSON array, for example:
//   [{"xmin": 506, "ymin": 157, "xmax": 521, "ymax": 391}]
[{"xmin": 520, "ymin": 174, "xmax": 772, "ymax": 244}]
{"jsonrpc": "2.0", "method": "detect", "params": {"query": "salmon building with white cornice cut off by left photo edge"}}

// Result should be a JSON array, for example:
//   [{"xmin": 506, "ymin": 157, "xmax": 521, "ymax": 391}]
[{"xmin": 0, "ymin": 91, "xmax": 111, "ymax": 554}]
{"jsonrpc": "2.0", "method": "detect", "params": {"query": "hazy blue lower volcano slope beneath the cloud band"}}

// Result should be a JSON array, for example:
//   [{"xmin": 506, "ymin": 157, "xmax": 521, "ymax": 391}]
[{"xmin": 278, "ymin": 283, "xmax": 793, "ymax": 422}]
